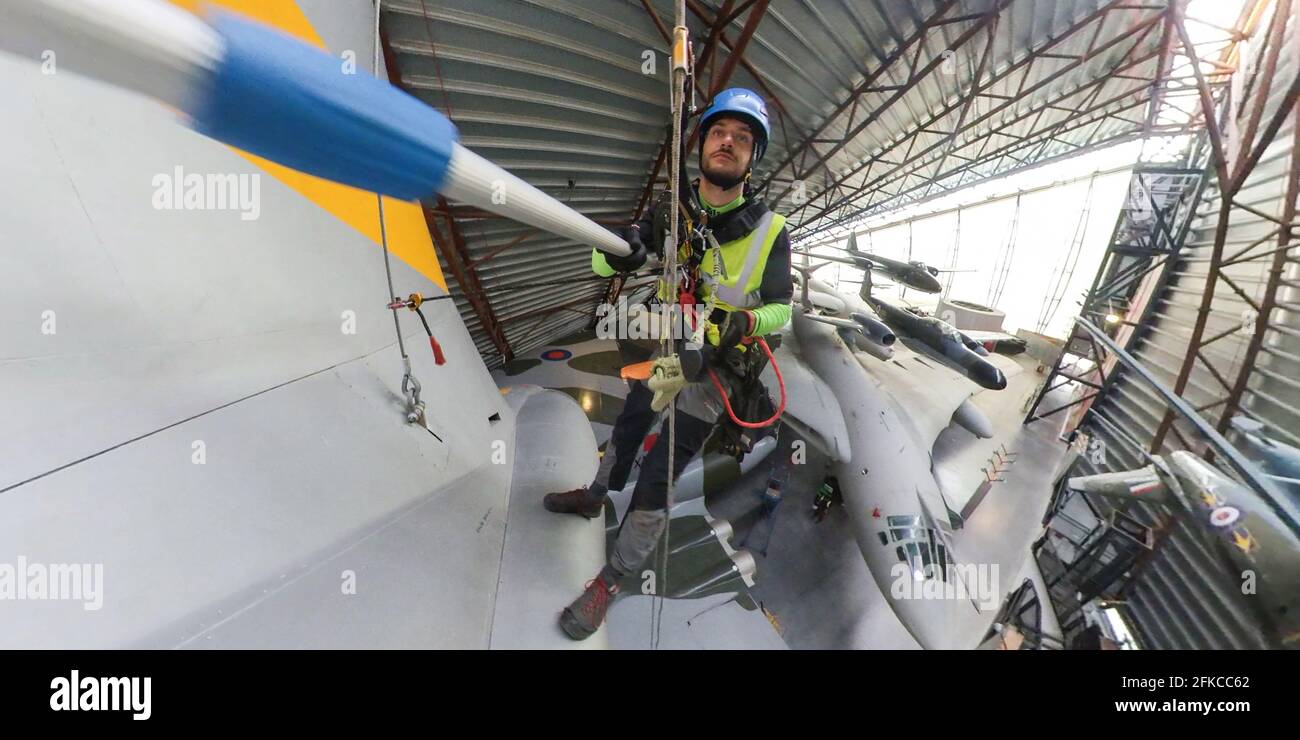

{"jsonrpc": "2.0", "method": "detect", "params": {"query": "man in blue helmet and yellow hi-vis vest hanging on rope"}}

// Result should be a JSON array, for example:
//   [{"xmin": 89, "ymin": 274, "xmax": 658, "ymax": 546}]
[{"xmin": 545, "ymin": 87, "xmax": 794, "ymax": 640}]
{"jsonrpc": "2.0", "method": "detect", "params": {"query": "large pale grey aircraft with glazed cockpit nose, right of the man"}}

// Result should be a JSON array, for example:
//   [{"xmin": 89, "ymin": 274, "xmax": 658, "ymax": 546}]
[{"xmin": 759, "ymin": 265, "xmax": 1019, "ymax": 648}]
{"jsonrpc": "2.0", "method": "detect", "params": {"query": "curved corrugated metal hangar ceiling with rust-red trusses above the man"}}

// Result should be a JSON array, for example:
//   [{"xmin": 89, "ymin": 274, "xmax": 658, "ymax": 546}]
[{"xmin": 382, "ymin": 0, "xmax": 1180, "ymax": 365}]
